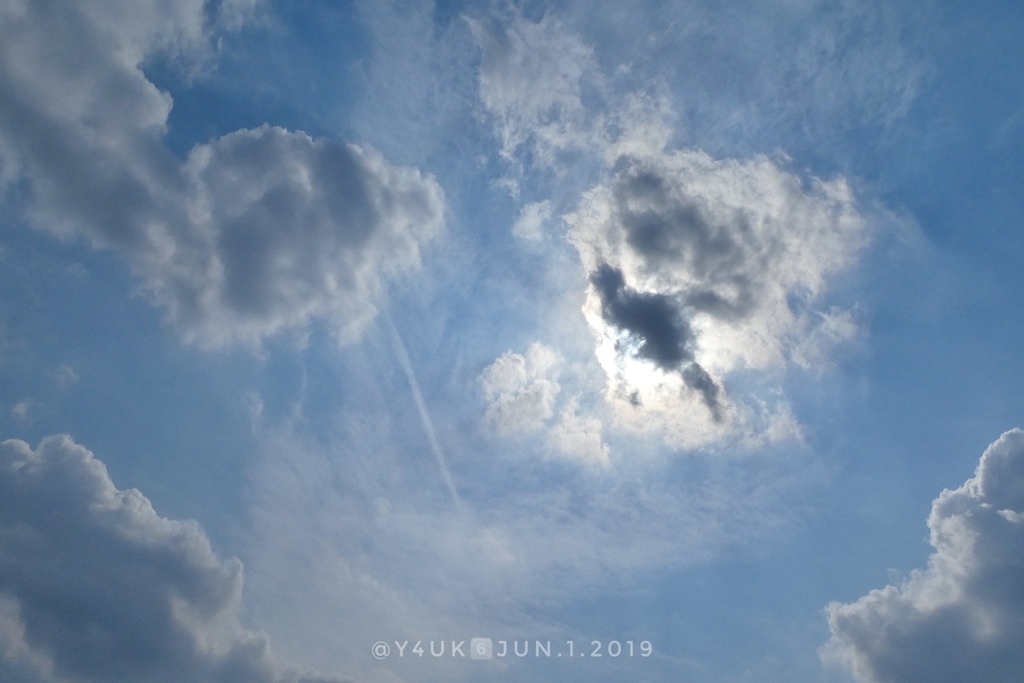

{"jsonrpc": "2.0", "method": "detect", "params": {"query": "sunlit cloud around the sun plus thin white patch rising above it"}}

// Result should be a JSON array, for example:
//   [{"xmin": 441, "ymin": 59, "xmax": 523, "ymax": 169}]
[{"xmin": 474, "ymin": 13, "xmax": 868, "ymax": 449}]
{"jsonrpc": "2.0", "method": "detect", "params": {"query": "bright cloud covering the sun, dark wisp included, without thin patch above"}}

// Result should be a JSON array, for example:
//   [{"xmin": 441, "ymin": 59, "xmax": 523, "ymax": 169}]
[{"xmin": 566, "ymin": 151, "xmax": 867, "ymax": 445}]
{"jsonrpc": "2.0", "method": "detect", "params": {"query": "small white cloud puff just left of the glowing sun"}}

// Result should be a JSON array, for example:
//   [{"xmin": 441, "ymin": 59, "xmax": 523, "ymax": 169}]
[{"xmin": 480, "ymin": 342, "xmax": 561, "ymax": 435}]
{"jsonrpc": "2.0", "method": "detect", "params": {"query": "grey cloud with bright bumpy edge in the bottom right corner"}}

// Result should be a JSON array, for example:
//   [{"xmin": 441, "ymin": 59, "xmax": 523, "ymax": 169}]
[{"xmin": 822, "ymin": 429, "xmax": 1024, "ymax": 683}]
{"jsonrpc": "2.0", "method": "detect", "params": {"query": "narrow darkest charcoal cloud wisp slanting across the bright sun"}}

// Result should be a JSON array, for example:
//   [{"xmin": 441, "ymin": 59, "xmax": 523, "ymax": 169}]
[{"xmin": 590, "ymin": 263, "xmax": 721, "ymax": 420}]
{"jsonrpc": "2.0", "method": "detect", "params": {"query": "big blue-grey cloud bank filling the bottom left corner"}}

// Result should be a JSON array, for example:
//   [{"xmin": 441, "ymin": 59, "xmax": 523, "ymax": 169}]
[{"xmin": 0, "ymin": 436, "xmax": 346, "ymax": 683}]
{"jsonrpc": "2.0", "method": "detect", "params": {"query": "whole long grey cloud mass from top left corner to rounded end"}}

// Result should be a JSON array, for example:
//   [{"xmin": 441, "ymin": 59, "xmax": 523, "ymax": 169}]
[{"xmin": 0, "ymin": 0, "xmax": 443, "ymax": 346}]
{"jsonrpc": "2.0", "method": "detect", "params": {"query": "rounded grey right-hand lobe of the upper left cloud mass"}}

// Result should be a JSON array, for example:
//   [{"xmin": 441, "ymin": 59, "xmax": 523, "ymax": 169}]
[{"xmin": 155, "ymin": 126, "xmax": 442, "ymax": 343}]
